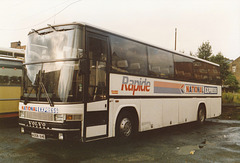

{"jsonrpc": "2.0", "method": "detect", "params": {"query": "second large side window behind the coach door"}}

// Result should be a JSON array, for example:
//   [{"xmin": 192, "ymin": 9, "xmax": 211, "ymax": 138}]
[{"xmin": 148, "ymin": 47, "xmax": 174, "ymax": 79}]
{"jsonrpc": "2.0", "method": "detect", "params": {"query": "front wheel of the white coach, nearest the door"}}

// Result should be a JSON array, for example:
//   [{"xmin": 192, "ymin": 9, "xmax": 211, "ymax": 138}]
[{"xmin": 116, "ymin": 112, "xmax": 135, "ymax": 140}]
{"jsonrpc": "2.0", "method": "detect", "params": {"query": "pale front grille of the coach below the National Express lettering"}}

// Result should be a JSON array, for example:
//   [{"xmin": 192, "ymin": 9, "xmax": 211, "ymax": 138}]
[{"xmin": 24, "ymin": 111, "xmax": 54, "ymax": 121}]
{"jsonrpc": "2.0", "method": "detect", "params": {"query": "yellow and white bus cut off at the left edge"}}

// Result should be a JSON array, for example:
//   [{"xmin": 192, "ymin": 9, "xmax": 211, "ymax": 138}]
[{"xmin": 0, "ymin": 53, "xmax": 24, "ymax": 119}]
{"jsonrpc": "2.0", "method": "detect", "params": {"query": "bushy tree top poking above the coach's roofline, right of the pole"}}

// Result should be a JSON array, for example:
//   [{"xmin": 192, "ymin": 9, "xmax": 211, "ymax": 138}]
[{"xmin": 197, "ymin": 41, "xmax": 212, "ymax": 60}]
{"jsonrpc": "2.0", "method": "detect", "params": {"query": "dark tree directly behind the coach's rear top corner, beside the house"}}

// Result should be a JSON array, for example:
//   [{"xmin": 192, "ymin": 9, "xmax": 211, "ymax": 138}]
[{"xmin": 209, "ymin": 52, "xmax": 230, "ymax": 83}]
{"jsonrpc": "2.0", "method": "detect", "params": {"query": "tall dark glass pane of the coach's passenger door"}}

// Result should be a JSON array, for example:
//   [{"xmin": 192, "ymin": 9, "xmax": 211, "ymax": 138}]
[{"xmin": 88, "ymin": 37, "xmax": 108, "ymax": 101}]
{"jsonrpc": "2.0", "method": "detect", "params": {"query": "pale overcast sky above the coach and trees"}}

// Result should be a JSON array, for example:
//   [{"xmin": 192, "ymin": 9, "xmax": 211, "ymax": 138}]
[{"xmin": 0, "ymin": 0, "xmax": 240, "ymax": 59}]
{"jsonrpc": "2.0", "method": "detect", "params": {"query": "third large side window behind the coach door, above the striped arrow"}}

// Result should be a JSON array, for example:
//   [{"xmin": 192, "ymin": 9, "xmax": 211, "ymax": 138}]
[{"xmin": 174, "ymin": 55, "xmax": 194, "ymax": 81}]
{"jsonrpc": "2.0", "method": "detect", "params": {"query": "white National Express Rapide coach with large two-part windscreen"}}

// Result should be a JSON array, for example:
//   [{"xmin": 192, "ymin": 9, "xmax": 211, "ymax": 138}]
[{"xmin": 19, "ymin": 23, "xmax": 221, "ymax": 142}]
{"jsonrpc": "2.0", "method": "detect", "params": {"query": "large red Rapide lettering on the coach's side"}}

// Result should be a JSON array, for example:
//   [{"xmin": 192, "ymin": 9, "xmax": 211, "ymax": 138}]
[{"xmin": 121, "ymin": 76, "xmax": 151, "ymax": 95}]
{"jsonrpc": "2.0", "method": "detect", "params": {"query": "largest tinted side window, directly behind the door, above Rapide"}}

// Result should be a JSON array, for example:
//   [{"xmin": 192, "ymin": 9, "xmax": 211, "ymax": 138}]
[{"xmin": 111, "ymin": 36, "xmax": 147, "ymax": 75}]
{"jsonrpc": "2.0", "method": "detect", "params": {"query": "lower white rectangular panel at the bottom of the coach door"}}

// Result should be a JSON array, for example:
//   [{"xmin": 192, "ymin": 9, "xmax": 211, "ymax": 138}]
[{"xmin": 86, "ymin": 125, "xmax": 107, "ymax": 138}]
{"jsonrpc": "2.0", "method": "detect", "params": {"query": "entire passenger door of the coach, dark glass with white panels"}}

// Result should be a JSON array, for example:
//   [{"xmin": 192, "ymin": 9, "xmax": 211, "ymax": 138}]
[{"xmin": 84, "ymin": 32, "xmax": 109, "ymax": 141}]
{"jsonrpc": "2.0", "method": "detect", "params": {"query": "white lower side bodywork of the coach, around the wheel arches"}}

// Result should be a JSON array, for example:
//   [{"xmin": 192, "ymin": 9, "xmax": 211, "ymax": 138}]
[{"xmin": 109, "ymin": 98, "xmax": 221, "ymax": 134}]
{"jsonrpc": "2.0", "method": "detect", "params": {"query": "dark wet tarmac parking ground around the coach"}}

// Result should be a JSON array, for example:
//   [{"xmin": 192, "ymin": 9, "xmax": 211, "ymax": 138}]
[{"xmin": 0, "ymin": 120, "xmax": 240, "ymax": 163}]
